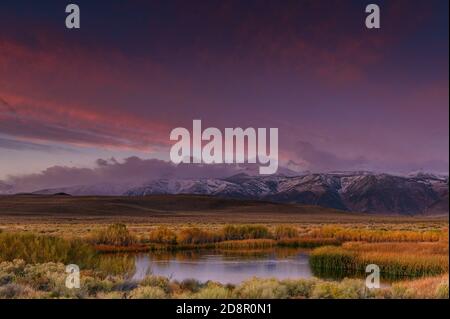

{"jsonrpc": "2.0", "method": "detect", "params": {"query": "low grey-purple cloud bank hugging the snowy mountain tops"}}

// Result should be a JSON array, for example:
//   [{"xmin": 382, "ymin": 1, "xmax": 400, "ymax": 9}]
[{"xmin": 0, "ymin": 153, "xmax": 448, "ymax": 192}]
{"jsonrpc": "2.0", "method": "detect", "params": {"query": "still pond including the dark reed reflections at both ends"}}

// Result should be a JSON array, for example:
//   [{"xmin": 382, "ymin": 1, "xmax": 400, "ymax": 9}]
[{"xmin": 100, "ymin": 247, "xmax": 394, "ymax": 285}]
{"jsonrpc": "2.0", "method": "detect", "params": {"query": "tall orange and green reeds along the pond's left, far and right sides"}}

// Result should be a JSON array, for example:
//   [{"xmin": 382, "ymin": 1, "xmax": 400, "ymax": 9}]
[{"xmin": 0, "ymin": 224, "xmax": 449, "ymax": 279}]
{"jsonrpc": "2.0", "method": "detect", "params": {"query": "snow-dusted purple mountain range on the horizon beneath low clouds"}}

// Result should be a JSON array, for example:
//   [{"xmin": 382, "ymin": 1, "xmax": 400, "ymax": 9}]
[{"xmin": 22, "ymin": 172, "xmax": 449, "ymax": 215}]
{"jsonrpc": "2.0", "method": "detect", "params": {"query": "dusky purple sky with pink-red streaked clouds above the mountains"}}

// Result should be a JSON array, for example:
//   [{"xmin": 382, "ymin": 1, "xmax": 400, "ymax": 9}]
[{"xmin": 0, "ymin": 0, "xmax": 449, "ymax": 190}]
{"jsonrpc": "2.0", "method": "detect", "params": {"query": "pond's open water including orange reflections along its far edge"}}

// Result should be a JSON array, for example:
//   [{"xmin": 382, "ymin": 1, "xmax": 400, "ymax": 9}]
[{"xmin": 131, "ymin": 249, "xmax": 313, "ymax": 284}]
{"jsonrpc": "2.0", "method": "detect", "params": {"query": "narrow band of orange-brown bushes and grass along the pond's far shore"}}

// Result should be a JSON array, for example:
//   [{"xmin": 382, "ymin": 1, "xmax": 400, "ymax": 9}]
[{"xmin": 88, "ymin": 224, "xmax": 448, "ymax": 252}]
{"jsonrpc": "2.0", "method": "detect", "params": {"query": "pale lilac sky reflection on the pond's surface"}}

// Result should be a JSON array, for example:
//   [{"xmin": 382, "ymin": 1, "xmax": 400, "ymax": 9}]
[{"xmin": 132, "ymin": 253, "xmax": 312, "ymax": 284}]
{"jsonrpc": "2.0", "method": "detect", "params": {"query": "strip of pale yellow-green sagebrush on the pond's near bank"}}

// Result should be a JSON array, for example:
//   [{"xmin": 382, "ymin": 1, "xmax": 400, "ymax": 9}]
[{"xmin": 0, "ymin": 260, "xmax": 449, "ymax": 299}]
